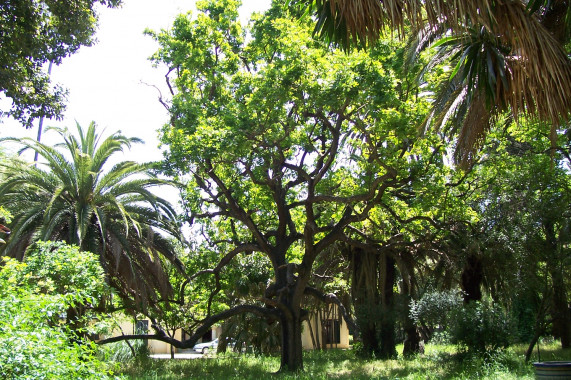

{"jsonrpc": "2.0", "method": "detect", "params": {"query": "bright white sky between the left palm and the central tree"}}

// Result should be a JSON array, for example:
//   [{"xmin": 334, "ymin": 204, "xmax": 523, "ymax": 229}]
[{"xmin": 0, "ymin": 0, "xmax": 270, "ymax": 162}]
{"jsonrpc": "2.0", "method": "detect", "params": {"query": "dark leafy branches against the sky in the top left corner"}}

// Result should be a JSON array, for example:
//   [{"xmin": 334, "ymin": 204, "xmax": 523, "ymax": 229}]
[{"xmin": 0, "ymin": 0, "xmax": 121, "ymax": 127}]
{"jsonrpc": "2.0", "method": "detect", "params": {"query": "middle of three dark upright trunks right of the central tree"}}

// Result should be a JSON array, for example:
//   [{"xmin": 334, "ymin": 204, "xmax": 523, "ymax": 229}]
[{"xmin": 380, "ymin": 254, "xmax": 397, "ymax": 359}]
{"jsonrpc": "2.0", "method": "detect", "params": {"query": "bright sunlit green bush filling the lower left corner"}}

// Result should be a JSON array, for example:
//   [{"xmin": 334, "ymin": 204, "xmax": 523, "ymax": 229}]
[{"xmin": 0, "ymin": 243, "xmax": 118, "ymax": 379}]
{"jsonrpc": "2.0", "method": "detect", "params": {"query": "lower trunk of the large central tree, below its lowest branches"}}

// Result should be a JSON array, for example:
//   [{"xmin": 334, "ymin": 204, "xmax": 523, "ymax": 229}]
[{"xmin": 280, "ymin": 310, "xmax": 303, "ymax": 372}]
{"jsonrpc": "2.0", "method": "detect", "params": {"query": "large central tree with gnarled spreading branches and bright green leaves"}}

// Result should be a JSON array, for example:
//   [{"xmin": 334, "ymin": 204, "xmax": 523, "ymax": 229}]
[{"xmin": 108, "ymin": 0, "xmax": 428, "ymax": 370}]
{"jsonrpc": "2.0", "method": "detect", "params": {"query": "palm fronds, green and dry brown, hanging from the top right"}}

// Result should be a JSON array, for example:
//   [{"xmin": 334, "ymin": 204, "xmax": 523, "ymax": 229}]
[{"xmin": 300, "ymin": 0, "xmax": 571, "ymax": 164}]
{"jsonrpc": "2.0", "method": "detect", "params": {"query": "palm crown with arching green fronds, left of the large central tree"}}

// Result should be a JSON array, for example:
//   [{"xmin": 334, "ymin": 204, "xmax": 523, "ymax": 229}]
[{"xmin": 0, "ymin": 123, "xmax": 182, "ymax": 309}]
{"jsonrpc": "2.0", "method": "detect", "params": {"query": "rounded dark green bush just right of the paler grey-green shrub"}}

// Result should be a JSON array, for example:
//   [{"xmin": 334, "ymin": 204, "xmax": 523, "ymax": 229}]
[{"xmin": 450, "ymin": 301, "xmax": 514, "ymax": 354}]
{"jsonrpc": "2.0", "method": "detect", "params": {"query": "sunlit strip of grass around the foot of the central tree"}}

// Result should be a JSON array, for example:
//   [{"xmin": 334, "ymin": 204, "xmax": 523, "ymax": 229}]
[{"xmin": 120, "ymin": 343, "xmax": 571, "ymax": 380}]
